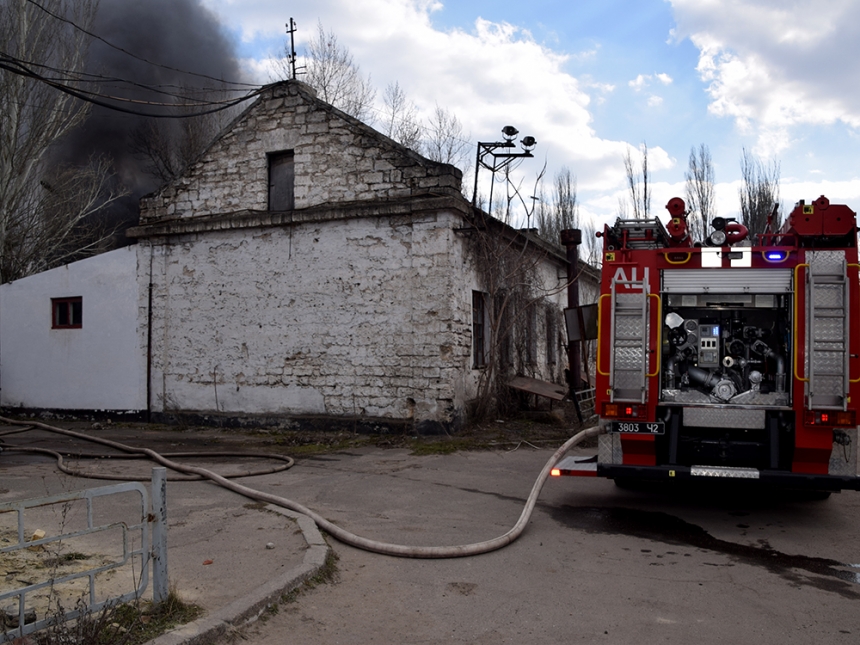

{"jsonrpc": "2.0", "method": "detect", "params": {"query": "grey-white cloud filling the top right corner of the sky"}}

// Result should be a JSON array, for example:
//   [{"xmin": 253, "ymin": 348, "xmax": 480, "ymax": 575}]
[{"xmin": 670, "ymin": 0, "xmax": 860, "ymax": 155}]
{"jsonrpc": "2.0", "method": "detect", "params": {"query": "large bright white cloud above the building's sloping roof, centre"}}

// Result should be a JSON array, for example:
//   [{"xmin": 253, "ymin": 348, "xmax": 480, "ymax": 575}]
[{"xmin": 203, "ymin": 0, "xmax": 672, "ymax": 221}]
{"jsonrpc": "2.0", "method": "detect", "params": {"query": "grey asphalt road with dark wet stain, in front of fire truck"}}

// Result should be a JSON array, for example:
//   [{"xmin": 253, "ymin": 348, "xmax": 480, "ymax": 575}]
[{"xmin": 227, "ymin": 446, "xmax": 860, "ymax": 645}]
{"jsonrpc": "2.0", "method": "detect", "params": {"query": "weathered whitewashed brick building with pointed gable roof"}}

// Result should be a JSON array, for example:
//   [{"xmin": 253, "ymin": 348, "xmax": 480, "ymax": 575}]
[{"xmin": 0, "ymin": 81, "xmax": 592, "ymax": 432}]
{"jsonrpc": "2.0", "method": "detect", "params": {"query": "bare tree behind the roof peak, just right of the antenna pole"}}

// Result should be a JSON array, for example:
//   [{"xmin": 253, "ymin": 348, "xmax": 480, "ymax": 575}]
[{"xmin": 275, "ymin": 22, "xmax": 376, "ymax": 123}]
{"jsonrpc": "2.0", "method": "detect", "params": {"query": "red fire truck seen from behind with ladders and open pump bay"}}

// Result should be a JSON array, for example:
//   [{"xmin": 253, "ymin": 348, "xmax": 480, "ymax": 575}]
[{"xmin": 553, "ymin": 196, "xmax": 860, "ymax": 491}]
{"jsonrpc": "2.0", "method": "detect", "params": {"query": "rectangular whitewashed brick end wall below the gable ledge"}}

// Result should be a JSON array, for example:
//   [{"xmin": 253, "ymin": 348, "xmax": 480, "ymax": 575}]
[{"xmin": 140, "ymin": 212, "xmax": 471, "ymax": 425}]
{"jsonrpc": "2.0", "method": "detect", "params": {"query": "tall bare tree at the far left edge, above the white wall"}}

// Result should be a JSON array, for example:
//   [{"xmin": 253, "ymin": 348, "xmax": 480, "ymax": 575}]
[{"xmin": 0, "ymin": 0, "xmax": 124, "ymax": 282}]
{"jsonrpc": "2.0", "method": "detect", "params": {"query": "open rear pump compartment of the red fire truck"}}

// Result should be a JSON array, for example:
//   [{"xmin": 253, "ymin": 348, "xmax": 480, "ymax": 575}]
[{"xmin": 657, "ymin": 293, "xmax": 794, "ymax": 470}]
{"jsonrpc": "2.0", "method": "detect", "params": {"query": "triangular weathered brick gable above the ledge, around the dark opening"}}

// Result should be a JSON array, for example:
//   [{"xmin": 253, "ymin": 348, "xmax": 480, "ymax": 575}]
[{"xmin": 141, "ymin": 81, "xmax": 462, "ymax": 223}]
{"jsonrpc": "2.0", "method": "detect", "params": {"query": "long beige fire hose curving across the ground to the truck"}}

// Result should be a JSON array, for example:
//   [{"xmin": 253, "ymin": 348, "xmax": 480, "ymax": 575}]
[{"xmin": 0, "ymin": 417, "xmax": 600, "ymax": 558}]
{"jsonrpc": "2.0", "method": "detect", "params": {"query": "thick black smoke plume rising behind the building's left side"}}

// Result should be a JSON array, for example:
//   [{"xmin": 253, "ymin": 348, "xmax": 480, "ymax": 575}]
[{"xmin": 57, "ymin": 0, "xmax": 242, "ymax": 238}]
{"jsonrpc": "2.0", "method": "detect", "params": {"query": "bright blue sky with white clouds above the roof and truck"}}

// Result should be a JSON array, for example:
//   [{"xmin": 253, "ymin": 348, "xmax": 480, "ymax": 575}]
[{"xmin": 202, "ymin": 0, "xmax": 860, "ymax": 231}]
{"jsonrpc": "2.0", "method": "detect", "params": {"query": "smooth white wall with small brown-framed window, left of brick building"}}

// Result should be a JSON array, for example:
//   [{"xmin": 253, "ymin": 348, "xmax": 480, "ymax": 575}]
[{"xmin": 0, "ymin": 246, "xmax": 146, "ymax": 411}]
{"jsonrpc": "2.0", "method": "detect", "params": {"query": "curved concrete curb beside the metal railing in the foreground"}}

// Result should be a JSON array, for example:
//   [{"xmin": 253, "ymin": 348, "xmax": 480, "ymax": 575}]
[{"xmin": 146, "ymin": 504, "xmax": 331, "ymax": 645}]
